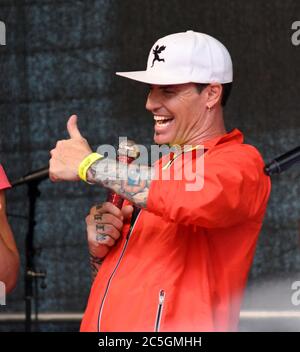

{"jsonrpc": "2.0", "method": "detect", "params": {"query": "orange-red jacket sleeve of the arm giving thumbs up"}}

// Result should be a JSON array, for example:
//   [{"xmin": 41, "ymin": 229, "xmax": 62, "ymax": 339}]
[{"xmin": 147, "ymin": 144, "xmax": 270, "ymax": 228}]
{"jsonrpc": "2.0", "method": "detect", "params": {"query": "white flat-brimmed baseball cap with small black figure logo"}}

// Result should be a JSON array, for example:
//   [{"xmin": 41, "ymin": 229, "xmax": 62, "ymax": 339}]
[{"xmin": 116, "ymin": 31, "xmax": 232, "ymax": 85}]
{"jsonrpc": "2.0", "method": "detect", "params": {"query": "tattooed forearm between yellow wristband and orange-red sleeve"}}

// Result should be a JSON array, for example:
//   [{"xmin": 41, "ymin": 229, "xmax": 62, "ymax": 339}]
[{"xmin": 87, "ymin": 159, "xmax": 154, "ymax": 208}]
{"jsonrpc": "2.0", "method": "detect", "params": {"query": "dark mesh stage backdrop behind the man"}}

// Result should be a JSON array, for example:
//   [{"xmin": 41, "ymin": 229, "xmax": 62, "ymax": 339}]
[{"xmin": 0, "ymin": 0, "xmax": 300, "ymax": 331}]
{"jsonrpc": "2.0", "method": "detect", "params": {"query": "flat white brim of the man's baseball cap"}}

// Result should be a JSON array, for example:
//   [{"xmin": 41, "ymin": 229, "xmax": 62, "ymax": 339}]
[{"xmin": 116, "ymin": 71, "xmax": 190, "ymax": 85}]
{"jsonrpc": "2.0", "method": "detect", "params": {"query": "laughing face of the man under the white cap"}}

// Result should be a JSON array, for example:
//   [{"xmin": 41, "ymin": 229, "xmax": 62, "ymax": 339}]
[{"xmin": 146, "ymin": 83, "xmax": 207, "ymax": 145}]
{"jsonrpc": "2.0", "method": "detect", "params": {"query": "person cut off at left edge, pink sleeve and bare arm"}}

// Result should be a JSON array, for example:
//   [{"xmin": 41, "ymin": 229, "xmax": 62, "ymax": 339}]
[{"xmin": 0, "ymin": 165, "xmax": 20, "ymax": 293}]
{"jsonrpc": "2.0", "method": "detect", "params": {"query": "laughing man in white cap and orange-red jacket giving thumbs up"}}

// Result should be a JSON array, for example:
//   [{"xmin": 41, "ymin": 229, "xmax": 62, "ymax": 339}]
[{"xmin": 50, "ymin": 31, "xmax": 270, "ymax": 331}]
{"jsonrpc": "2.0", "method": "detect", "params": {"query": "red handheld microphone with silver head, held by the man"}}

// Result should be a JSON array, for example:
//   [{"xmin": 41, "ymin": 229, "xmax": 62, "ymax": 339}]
[{"xmin": 106, "ymin": 139, "xmax": 140, "ymax": 209}]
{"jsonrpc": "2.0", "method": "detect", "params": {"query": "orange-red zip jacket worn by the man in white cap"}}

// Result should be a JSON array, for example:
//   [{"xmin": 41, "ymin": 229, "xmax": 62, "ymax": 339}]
[{"xmin": 81, "ymin": 129, "xmax": 271, "ymax": 331}]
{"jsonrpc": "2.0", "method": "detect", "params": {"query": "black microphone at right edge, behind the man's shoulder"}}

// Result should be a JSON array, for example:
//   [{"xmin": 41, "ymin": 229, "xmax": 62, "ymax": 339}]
[{"xmin": 264, "ymin": 146, "xmax": 300, "ymax": 176}]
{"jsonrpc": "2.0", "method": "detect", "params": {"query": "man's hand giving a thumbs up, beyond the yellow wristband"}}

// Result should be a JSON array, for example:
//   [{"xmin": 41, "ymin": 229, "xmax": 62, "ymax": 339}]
[{"xmin": 49, "ymin": 115, "xmax": 92, "ymax": 182}]
